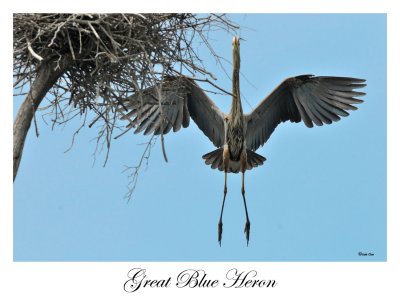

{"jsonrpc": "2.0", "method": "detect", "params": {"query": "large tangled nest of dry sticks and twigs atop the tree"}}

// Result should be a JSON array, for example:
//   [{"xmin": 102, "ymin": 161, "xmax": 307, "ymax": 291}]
[{"xmin": 13, "ymin": 14, "xmax": 237, "ymax": 197}]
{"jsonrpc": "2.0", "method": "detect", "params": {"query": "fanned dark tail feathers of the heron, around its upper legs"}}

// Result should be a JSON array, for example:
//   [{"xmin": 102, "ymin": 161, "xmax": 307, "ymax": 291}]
[{"xmin": 203, "ymin": 147, "xmax": 266, "ymax": 173}]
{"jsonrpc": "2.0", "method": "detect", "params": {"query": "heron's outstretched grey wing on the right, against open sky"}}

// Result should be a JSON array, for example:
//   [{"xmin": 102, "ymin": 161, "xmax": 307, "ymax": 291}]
[{"xmin": 245, "ymin": 75, "xmax": 366, "ymax": 151}]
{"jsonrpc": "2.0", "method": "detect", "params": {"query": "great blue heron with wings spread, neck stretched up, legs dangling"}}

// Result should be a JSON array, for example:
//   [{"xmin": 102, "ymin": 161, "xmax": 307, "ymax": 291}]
[{"xmin": 123, "ymin": 36, "xmax": 365, "ymax": 245}]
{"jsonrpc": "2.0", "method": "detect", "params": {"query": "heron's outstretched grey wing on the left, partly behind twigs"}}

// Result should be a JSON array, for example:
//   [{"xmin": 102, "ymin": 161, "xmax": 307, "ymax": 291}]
[{"xmin": 122, "ymin": 77, "xmax": 224, "ymax": 147}]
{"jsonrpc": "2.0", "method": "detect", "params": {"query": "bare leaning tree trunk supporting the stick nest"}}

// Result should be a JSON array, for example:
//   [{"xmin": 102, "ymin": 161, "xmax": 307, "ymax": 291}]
[{"xmin": 13, "ymin": 58, "xmax": 70, "ymax": 180}]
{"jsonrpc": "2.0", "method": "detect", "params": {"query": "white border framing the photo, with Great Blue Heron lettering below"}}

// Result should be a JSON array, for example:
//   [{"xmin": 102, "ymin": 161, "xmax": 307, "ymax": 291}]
[{"xmin": 0, "ymin": 0, "xmax": 400, "ymax": 300}]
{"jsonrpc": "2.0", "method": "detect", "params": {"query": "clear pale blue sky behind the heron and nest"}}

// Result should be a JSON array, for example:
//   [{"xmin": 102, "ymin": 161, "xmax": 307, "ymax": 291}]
[{"xmin": 14, "ymin": 14, "xmax": 386, "ymax": 261}]
